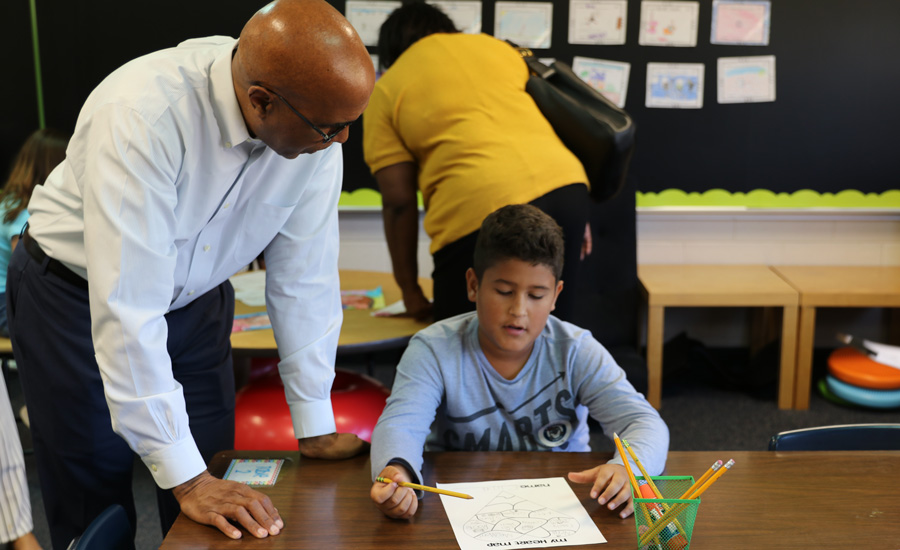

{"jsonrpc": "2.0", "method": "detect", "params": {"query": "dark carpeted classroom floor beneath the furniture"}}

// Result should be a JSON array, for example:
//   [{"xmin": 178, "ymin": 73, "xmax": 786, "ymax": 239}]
[{"xmin": 7, "ymin": 348, "xmax": 897, "ymax": 550}]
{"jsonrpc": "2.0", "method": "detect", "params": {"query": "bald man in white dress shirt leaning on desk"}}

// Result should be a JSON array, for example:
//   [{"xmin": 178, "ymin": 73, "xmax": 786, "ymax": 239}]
[{"xmin": 7, "ymin": 0, "xmax": 375, "ymax": 548}]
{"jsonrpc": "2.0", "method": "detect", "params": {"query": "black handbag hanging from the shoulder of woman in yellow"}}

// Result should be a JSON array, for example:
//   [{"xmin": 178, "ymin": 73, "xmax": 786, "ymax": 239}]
[{"xmin": 510, "ymin": 42, "xmax": 635, "ymax": 202}]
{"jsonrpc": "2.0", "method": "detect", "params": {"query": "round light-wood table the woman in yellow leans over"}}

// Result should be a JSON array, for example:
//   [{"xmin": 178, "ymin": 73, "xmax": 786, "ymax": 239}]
[{"xmin": 231, "ymin": 270, "xmax": 431, "ymax": 357}]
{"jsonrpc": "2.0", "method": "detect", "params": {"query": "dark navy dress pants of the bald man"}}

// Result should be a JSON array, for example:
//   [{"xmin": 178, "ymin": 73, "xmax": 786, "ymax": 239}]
[{"xmin": 7, "ymin": 246, "xmax": 234, "ymax": 549}]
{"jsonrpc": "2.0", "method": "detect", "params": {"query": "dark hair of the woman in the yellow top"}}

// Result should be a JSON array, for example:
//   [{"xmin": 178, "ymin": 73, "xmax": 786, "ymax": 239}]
[{"xmin": 378, "ymin": 0, "xmax": 459, "ymax": 70}]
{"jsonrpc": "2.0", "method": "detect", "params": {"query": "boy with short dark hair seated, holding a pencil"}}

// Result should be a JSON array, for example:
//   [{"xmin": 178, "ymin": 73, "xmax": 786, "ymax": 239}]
[{"xmin": 370, "ymin": 205, "xmax": 669, "ymax": 519}]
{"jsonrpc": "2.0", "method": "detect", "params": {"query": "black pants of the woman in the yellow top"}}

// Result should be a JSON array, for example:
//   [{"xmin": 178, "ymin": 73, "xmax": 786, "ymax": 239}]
[{"xmin": 432, "ymin": 183, "xmax": 591, "ymax": 321}]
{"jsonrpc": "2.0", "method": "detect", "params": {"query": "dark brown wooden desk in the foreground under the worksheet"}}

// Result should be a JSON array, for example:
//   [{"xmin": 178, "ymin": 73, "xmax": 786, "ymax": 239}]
[{"xmin": 161, "ymin": 451, "xmax": 900, "ymax": 550}]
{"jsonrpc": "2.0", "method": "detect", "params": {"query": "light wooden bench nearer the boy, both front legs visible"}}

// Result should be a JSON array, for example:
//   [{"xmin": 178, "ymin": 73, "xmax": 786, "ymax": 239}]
[{"xmin": 638, "ymin": 265, "xmax": 798, "ymax": 409}]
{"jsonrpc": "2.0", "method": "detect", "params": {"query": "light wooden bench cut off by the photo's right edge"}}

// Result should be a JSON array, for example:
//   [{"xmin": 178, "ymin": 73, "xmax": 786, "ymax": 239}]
[{"xmin": 772, "ymin": 265, "xmax": 900, "ymax": 409}]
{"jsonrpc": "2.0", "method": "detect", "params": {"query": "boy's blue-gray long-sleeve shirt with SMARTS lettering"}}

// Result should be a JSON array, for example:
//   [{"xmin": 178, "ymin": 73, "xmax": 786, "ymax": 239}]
[{"xmin": 371, "ymin": 313, "xmax": 669, "ymax": 488}]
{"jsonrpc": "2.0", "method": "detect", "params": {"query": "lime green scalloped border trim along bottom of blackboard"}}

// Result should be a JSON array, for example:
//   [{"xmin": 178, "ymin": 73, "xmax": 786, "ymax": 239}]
[{"xmin": 338, "ymin": 188, "xmax": 900, "ymax": 209}]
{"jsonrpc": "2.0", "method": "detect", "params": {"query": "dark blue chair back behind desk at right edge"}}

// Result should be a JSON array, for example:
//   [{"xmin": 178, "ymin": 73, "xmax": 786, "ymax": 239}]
[{"xmin": 769, "ymin": 424, "xmax": 900, "ymax": 451}]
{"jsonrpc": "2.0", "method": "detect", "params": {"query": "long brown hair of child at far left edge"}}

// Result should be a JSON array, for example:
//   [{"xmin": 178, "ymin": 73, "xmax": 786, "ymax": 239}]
[{"xmin": 0, "ymin": 128, "xmax": 69, "ymax": 223}]
